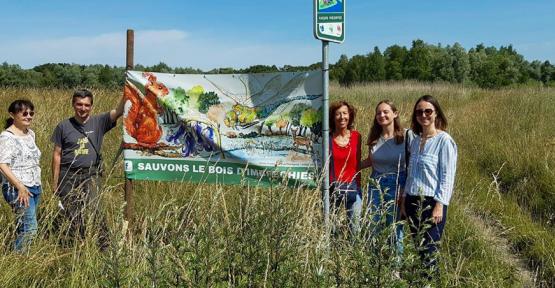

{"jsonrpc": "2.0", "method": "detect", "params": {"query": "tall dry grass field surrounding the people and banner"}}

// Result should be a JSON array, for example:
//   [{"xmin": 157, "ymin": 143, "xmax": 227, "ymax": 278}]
[{"xmin": 0, "ymin": 82, "xmax": 555, "ymax": 287}]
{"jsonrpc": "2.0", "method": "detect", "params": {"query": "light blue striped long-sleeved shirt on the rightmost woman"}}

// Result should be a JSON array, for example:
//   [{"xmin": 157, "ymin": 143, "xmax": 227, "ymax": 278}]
[{"xmin": 405, "ymin": 131, "xmax": 457, "ymax": 205}]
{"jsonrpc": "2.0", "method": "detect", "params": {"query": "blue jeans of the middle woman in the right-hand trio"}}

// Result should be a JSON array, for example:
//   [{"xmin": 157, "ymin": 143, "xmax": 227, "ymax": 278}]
[{"xmin": 368, "ymin": 171, "xmax": 406, "ymax": 260}]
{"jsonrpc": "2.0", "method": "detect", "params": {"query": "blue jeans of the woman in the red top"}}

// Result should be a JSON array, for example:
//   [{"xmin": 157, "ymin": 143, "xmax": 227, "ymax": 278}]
[{"xmin": 330, "ymin": 181, "xmax": 362, "ymax": 235}]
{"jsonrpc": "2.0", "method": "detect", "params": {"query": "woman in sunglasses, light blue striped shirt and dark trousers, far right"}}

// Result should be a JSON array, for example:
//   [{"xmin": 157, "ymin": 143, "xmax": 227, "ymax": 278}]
[{"xmin": 404, "ymin": 95, "xmax": 457, "ymax": 280}]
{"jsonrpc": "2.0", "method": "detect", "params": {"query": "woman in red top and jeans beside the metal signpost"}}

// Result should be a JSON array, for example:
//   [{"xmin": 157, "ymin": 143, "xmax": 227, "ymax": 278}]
[{"xmin": 329, "ymin": 101, "xmax": 362, "ymax": 234}]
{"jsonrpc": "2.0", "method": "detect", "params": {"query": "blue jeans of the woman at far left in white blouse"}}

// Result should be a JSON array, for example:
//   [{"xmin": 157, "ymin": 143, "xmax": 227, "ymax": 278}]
[{"xmin": 2, "ymin": 183, "xmax": 42, "ymax": 251}]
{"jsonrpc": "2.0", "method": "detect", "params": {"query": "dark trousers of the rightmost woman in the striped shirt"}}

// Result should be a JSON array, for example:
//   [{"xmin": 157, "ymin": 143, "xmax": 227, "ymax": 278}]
[{"xmin": 405, "ymin": 195, "xmax": 447, "ymax": 279}]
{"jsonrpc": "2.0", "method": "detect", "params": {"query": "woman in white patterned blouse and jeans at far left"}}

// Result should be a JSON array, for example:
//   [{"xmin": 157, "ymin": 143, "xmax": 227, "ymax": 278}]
[{"xmin": 0, "ymin": 100, "xmax": 42, "ymax": 251}]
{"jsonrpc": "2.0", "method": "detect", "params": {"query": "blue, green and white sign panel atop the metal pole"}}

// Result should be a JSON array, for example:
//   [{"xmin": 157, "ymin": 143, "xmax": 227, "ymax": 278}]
[{"xmin": 314, "ymin": 0, "xmax": 345, "ymax": 43}]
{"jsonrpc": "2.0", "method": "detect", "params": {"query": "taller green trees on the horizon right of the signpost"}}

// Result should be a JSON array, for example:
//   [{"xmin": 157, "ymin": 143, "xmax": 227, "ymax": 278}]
[{"xmin": 330, "ymin": 40, "xmax": 555, "ymax": 88}]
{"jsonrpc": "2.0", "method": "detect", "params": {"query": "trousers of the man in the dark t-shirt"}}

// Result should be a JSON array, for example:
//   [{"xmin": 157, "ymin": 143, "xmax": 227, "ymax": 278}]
[{"xmin": 56, "ymin": 170, "xmax": 108, "ymax": 248}]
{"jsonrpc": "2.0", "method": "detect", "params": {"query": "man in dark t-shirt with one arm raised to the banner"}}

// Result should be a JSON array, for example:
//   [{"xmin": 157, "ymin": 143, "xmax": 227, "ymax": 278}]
[{"xmin": 52, "ymin": 89, "xmax": 124, "ymax": 245}]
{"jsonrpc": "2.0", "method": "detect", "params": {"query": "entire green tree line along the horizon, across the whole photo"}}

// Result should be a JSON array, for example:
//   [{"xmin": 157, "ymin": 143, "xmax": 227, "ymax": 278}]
[{"xmin": 0, "ymin": 40, "xmax": 555, "ymax": 88}]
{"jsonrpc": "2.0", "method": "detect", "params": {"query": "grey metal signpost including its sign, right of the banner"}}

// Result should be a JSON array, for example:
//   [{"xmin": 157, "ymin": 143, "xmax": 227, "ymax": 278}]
[{"xmin": 314, "ymin": 0, "xmax": 345, "ymax": 227}]
